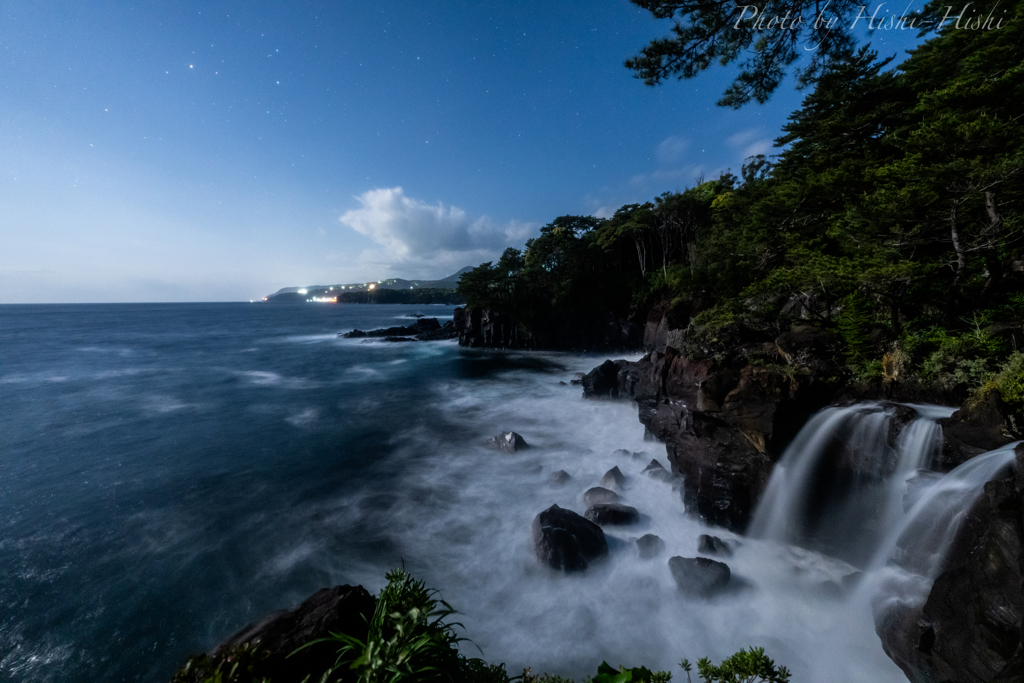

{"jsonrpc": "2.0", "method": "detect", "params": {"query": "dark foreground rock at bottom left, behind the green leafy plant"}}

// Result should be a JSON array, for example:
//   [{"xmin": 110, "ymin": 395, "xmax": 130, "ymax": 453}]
[{"xmin": 174, "ymin": 586, "xmax": 374, "ymax": 683}]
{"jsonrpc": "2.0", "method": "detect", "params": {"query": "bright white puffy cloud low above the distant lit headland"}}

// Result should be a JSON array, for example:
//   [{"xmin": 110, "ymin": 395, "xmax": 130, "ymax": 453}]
[{"xmin": 339, "ymin": 187, "xmax": 537, "ymax": 278}]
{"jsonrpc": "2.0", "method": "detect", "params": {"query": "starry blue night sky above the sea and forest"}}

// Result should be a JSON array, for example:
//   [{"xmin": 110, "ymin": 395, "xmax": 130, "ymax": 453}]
[{"xmin": 0, "ymin": 0, "xmax": 929, "ymax": 303}]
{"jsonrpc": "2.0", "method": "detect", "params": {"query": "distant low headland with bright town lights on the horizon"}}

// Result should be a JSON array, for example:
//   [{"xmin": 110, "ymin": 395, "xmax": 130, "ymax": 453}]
[{"xmin": 263, "ymin": 266, "xmax": 473, "ymax": 304}]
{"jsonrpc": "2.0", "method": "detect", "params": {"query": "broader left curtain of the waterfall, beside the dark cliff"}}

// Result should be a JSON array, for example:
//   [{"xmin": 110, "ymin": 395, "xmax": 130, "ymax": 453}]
[{"xmin": 750, "ymin": 403, "xmax": 953, "ymax": 566}]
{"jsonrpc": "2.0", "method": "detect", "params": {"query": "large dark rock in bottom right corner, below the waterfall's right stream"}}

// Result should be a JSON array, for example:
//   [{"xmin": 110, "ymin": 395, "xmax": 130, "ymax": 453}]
[{"xmin": 876, "ymin": 445, "xmax": 1024, "ymax": 683}]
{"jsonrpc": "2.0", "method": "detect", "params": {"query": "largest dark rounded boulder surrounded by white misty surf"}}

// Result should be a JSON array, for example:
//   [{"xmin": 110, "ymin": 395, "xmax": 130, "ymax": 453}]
[{"xmin": 531, "ymin": 505, "xmax": 608, "ymax": 571}]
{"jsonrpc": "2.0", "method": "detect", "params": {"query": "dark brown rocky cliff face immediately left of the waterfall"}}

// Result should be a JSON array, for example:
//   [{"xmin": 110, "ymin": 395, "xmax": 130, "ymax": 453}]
[{"xmin": 584, "ymin": 321, "xmax": 843, "ymax": 531}]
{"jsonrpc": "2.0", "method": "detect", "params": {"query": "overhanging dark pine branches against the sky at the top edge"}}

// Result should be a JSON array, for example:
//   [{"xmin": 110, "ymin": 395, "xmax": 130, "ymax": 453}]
[{"xmin": 626, "ymin": 0, "xmax": 917, "ymax": 109}]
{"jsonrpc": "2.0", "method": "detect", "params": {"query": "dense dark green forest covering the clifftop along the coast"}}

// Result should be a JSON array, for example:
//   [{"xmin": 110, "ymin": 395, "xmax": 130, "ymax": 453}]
[{"xmin": 459, "ymin": 2, "xmax": 1024, "ymax": 409}]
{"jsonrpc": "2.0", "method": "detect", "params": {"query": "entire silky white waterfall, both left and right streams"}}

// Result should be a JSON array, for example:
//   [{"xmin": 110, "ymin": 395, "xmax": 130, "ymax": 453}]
[{"xmin": 750, "ymin": 403, "xmax": 1019, "ymax": 651}]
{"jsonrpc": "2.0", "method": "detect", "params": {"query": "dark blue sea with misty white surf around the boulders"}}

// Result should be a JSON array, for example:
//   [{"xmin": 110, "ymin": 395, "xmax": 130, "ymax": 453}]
[{"xmin": 0, "ymin": 304, "xmax": 929, "ymax": 683}]
